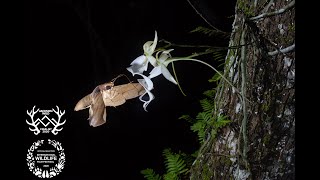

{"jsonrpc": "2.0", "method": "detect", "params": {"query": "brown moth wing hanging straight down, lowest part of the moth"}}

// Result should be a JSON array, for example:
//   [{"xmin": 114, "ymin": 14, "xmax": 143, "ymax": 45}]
[{"xmin": 88, "ymin": 93, "xmax": 107, "ymax": 127}]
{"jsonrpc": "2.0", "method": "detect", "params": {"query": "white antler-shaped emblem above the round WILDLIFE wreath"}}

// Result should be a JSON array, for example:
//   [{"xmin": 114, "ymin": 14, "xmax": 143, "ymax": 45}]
[{"xmin": 26, "ymin": 106, "xmax": 66, "ymax": 135}]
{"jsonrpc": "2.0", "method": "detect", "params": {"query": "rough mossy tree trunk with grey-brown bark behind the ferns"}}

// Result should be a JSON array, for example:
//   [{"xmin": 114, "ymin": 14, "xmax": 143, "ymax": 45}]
[{"xmin": 190, "ymin": 0, "xmax": 295, "ymax": 180}]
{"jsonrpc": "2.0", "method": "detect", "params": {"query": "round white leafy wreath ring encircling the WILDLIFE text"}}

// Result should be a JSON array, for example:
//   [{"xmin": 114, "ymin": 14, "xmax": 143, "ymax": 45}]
[{"xmin": 27, "ymin": 139, "xmax": 66, "ymax": 178}]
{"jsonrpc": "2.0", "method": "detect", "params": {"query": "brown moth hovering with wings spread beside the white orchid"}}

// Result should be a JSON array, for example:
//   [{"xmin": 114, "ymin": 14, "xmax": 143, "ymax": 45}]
[{"xmin": 74, "ymin": 74, "xmax": 145, "ymax": 127}]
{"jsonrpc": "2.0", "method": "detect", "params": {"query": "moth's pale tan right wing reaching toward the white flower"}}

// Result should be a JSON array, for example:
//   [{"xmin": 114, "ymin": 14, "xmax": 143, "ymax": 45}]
[{"xmin": 102, "ymin": 83, "xmax": 144, "ymax": 107}]
